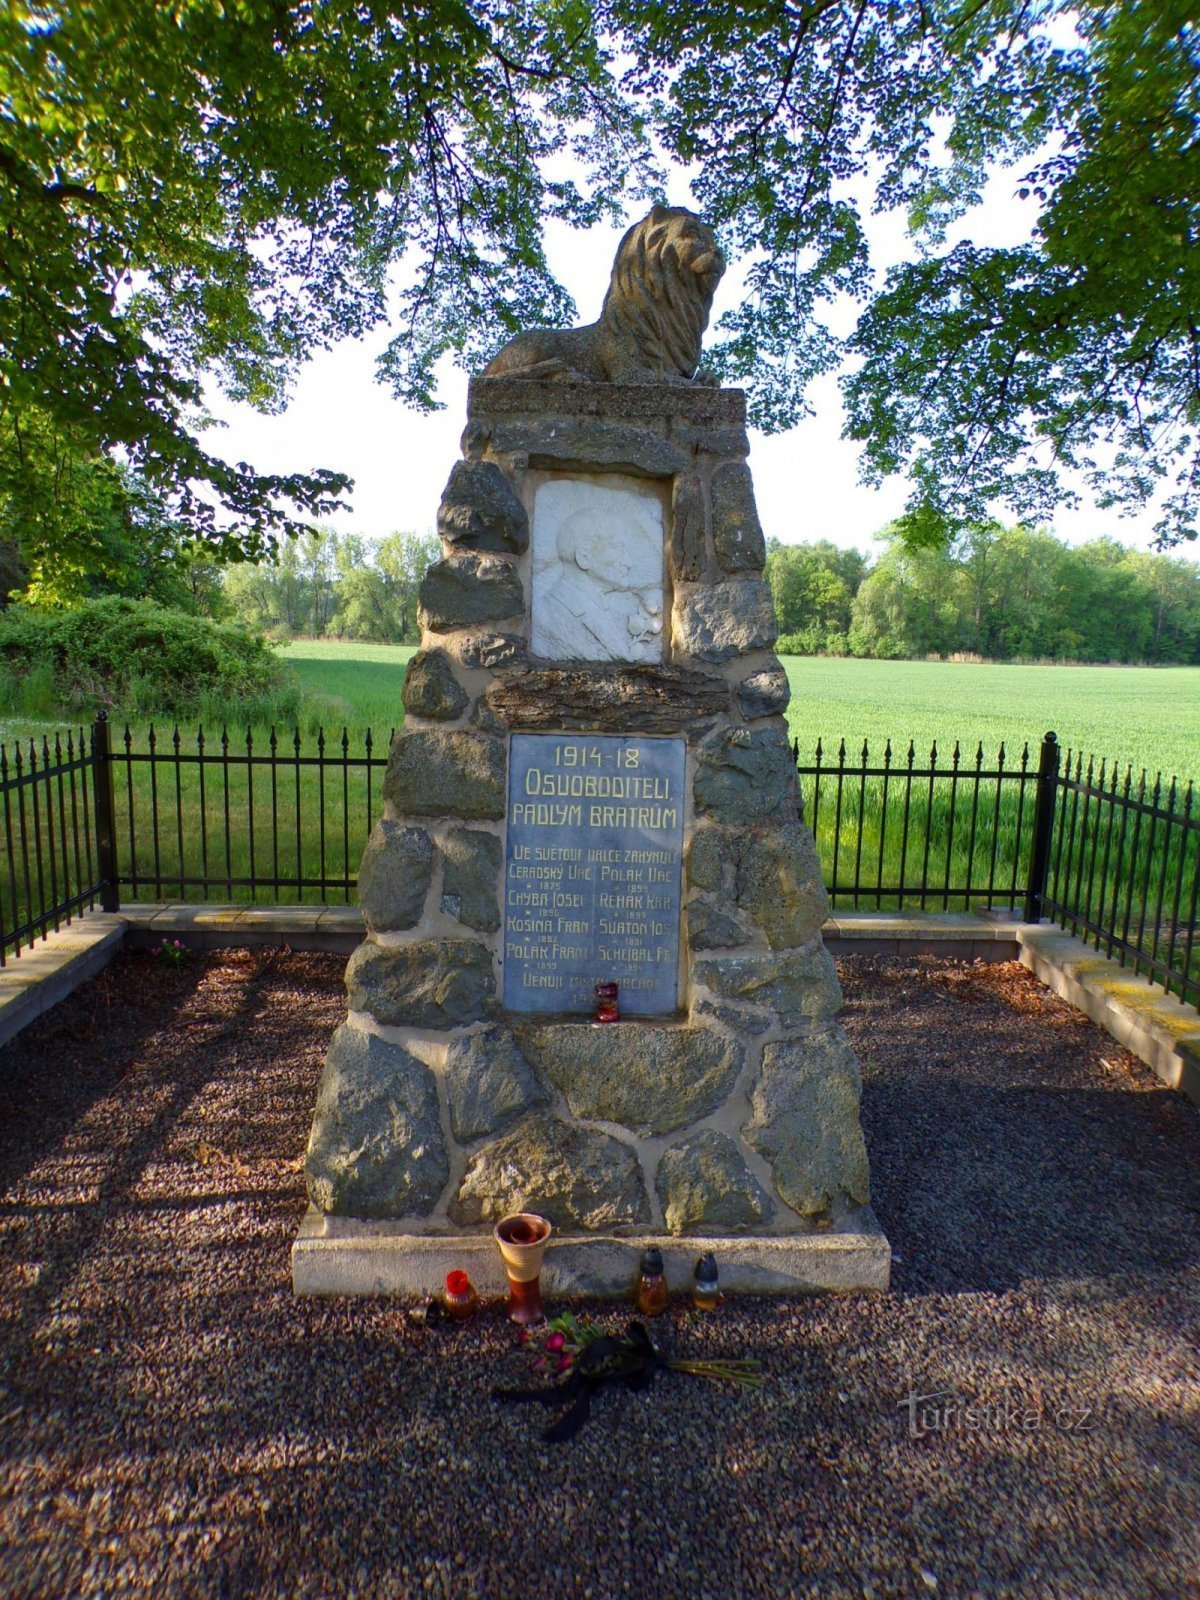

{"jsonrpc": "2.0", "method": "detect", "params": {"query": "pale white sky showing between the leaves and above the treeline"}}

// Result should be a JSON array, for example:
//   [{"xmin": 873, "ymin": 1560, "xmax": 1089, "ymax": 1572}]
[{"xmin": 208, "ymin": 170, "xmax": 1177, "ymax": 563}]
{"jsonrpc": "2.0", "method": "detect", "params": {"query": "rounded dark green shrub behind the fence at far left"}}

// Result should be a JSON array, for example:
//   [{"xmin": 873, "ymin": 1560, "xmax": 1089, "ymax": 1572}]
[{"xmin": 0, "ymin": 595, "xmax": 299, "ymax": 720}]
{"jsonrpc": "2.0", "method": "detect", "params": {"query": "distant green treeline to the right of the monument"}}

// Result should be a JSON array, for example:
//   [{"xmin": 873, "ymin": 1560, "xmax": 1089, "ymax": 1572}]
[{"xmin": 766, "ymin": 523, "xmax": 1200, "ymax": 666}]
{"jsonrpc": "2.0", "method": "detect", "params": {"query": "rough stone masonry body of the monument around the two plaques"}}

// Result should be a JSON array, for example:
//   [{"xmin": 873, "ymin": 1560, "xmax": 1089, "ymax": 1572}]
[{"xmin": 307, "ymin": 379, "xmax": 869, "ymax": 1234}]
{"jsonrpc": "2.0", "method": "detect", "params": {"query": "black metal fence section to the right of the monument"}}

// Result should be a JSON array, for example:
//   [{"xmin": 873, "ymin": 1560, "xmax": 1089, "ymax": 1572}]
[{"xmin": 794, "ymin": 733, "xmax": 1200, "ymax": 1005}]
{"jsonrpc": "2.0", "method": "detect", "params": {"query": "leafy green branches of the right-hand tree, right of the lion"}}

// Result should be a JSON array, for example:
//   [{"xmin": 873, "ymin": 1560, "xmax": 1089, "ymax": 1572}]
[{"xmin": 610, "ymin": 0, "xmax": 1200, "ymax": 544}]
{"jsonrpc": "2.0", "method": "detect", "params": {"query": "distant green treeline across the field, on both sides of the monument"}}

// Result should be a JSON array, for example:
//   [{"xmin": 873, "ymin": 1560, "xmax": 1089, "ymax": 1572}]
[{"xmin": 232, "ymin": 523, "xmax": 1200, "ymax": 666}]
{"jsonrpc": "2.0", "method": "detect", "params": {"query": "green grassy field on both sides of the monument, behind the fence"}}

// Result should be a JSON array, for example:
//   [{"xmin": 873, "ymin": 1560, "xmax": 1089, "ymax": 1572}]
[{"xmin": 0, "ymin": 642, "xmax": 1200, "ymax": 985}]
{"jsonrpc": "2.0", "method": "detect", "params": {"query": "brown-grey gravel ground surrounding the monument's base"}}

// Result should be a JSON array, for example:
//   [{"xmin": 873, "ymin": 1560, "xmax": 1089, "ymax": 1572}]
[{"xmin": 0, "ymin": 950, "xmax": 1200, "ymax": 1600}]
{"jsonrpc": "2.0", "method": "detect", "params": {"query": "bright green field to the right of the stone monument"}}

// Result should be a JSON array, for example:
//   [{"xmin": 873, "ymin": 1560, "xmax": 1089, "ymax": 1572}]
[{"xmin": 784, "ymin": 658, "xmax": 1200, "ymax": 940}]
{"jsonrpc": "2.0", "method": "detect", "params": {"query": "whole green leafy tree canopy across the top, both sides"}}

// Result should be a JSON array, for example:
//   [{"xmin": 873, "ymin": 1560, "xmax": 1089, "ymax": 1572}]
[{"xmin": 0, "ymin": 0, "xmax": 1200, "ymax": 569}]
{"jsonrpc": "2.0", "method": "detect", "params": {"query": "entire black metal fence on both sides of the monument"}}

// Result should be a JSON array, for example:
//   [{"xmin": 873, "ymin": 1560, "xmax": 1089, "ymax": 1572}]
[{"xmin": 0, "ymin": 717, "xmax": 1200, "ymax": 1003}]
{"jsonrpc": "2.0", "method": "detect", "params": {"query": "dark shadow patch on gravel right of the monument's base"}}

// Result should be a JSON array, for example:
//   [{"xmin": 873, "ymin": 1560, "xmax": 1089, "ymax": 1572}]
[{"xmin": 862, "ymin": 1078, "xmax": 1200, "ymax": 1293}]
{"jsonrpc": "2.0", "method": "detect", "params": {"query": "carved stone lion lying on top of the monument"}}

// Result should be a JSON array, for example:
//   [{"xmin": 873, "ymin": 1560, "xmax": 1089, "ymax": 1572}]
[{"xmin": 483, "ymin": 205, "xmax": 725, "ymax": 384}]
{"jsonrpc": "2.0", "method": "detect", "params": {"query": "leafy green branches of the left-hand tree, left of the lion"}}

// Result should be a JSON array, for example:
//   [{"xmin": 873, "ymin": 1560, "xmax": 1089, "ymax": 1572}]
[{"xmin": 0, "ymin": 0, "xmax": 624, "ymax": 558}]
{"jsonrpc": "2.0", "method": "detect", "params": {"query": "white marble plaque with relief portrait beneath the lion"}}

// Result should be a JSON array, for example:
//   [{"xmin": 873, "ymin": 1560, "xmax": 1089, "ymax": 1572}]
[{"xmin": 530, "ymin": 477, "xmax": 664, "ymax": 661}]
